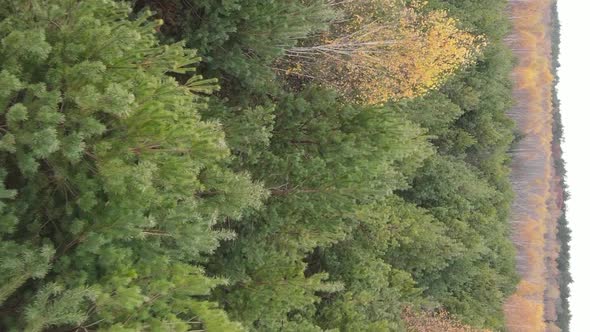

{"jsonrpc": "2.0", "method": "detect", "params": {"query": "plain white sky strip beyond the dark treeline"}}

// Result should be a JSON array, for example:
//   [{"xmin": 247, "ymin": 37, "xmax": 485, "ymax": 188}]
[{"xmin": 558, "ymin": 0, "xmax": 590, "ymax": 332}]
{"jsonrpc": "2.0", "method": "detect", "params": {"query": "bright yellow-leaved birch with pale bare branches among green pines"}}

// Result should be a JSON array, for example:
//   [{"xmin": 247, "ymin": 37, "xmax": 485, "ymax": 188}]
[{"xmin": 287, "ymin": 0, "xmax": 485, "ymax": 104}]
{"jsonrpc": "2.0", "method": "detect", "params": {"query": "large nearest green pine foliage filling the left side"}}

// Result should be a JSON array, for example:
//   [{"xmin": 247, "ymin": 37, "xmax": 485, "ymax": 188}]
[{"xmin": 0, "ymin": 0, "xmax": 265, "ymax": 331}]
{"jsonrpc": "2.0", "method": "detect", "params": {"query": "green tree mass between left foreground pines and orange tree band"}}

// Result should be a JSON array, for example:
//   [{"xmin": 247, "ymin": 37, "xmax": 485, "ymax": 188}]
[{"xmin": 141, "ymin": 1, "xmax": 516, "ymax": 331}]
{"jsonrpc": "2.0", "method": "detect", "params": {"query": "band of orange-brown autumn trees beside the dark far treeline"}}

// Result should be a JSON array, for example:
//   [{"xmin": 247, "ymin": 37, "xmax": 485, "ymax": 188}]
[{"xmin": 504, "ymin": 0, "xmax": 561, "ymax": 332}]
